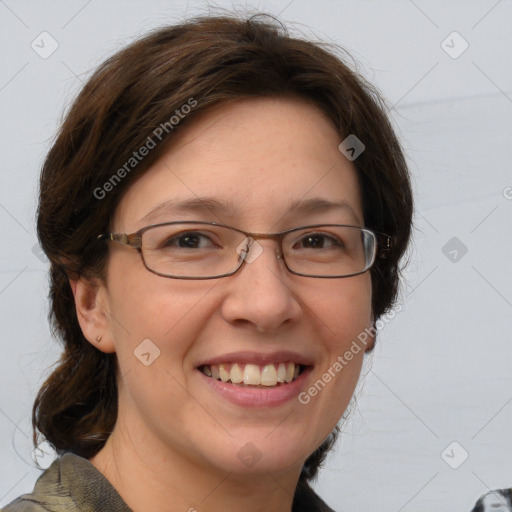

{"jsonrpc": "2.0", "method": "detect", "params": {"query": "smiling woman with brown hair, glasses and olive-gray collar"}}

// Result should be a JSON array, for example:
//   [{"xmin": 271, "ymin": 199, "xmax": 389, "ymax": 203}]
[{"xmin": 4, "ymin": 12, "xmax": 412, "ymax": 512}]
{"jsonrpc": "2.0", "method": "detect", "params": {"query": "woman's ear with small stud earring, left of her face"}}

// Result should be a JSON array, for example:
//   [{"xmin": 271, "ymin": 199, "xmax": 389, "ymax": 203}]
[{"xmin": 69, "ymin": 276, "xmax": 115, "ymax": 353}]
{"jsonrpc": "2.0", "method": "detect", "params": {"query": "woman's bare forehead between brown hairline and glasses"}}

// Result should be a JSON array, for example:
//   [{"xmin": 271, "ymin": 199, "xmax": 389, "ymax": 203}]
[{"xmin": 114, "ymin": 98, "xmax": 363, "ymax": 230}]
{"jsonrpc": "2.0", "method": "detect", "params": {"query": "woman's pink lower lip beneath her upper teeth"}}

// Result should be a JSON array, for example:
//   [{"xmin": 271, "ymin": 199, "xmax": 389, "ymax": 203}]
[{"xmin": 197, "ymin": 368, "xmax": 311, "ymax": 407}]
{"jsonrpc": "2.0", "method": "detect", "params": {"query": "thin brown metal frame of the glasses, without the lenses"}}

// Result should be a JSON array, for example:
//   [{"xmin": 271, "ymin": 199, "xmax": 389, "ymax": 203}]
[{"xmin": 97, "ymin": 220, "xmax": 391, "ymax": 280}]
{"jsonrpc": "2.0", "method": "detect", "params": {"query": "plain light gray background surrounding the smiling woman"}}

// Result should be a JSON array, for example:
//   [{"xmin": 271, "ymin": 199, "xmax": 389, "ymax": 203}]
[{"xmin": 0, "ymin": 0, "xmax": 512, "ymax": 512}]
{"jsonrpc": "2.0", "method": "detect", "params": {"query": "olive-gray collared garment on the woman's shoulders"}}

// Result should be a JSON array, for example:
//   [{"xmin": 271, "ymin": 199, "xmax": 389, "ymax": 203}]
[{"xmin": 1, "ymin": 452, "xmax": 334, "ymax": 512}]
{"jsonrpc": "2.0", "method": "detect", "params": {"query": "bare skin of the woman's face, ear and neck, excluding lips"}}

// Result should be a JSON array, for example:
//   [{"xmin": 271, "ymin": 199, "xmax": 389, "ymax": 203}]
[{"xmin": 71, "ymin": 98, "xmax": 372, "ymax": 512}]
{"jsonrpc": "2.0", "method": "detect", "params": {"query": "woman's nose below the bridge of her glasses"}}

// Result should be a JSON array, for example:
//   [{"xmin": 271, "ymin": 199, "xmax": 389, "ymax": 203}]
[{"xmin": 221, "ymin": 240, "xmax": 302, "ymax": 332}]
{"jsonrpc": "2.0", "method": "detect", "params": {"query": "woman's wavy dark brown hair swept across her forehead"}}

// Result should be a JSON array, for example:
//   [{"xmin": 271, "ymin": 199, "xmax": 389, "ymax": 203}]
[{"xmin": 32, "ymin": 11, "xmax": 412, "ymax": 500}]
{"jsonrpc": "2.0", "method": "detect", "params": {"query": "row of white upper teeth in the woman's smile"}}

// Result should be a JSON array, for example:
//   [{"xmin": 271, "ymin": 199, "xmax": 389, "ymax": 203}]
[{"xmin": 201, "ymin": 363, "xmax": 300, "ymax": 386}]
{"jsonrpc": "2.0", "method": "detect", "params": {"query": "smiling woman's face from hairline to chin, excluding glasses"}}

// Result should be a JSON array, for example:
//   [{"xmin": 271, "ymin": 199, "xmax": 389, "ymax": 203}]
[{"xmin": 97, "ymin": 99, "xmax": 372, "ymax": 473}]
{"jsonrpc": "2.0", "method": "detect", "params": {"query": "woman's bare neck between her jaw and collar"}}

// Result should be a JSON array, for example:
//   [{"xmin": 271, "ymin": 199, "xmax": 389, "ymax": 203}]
[{"xmin": 90, "ymin": 406, "xmax": 302, "ymax": 512}]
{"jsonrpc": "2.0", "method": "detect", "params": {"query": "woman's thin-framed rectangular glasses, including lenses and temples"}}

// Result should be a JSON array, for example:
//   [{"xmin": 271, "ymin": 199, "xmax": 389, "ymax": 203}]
[{"xmin": 98, "ymin": 221, "xmax": 391, "ymax": 279}]
